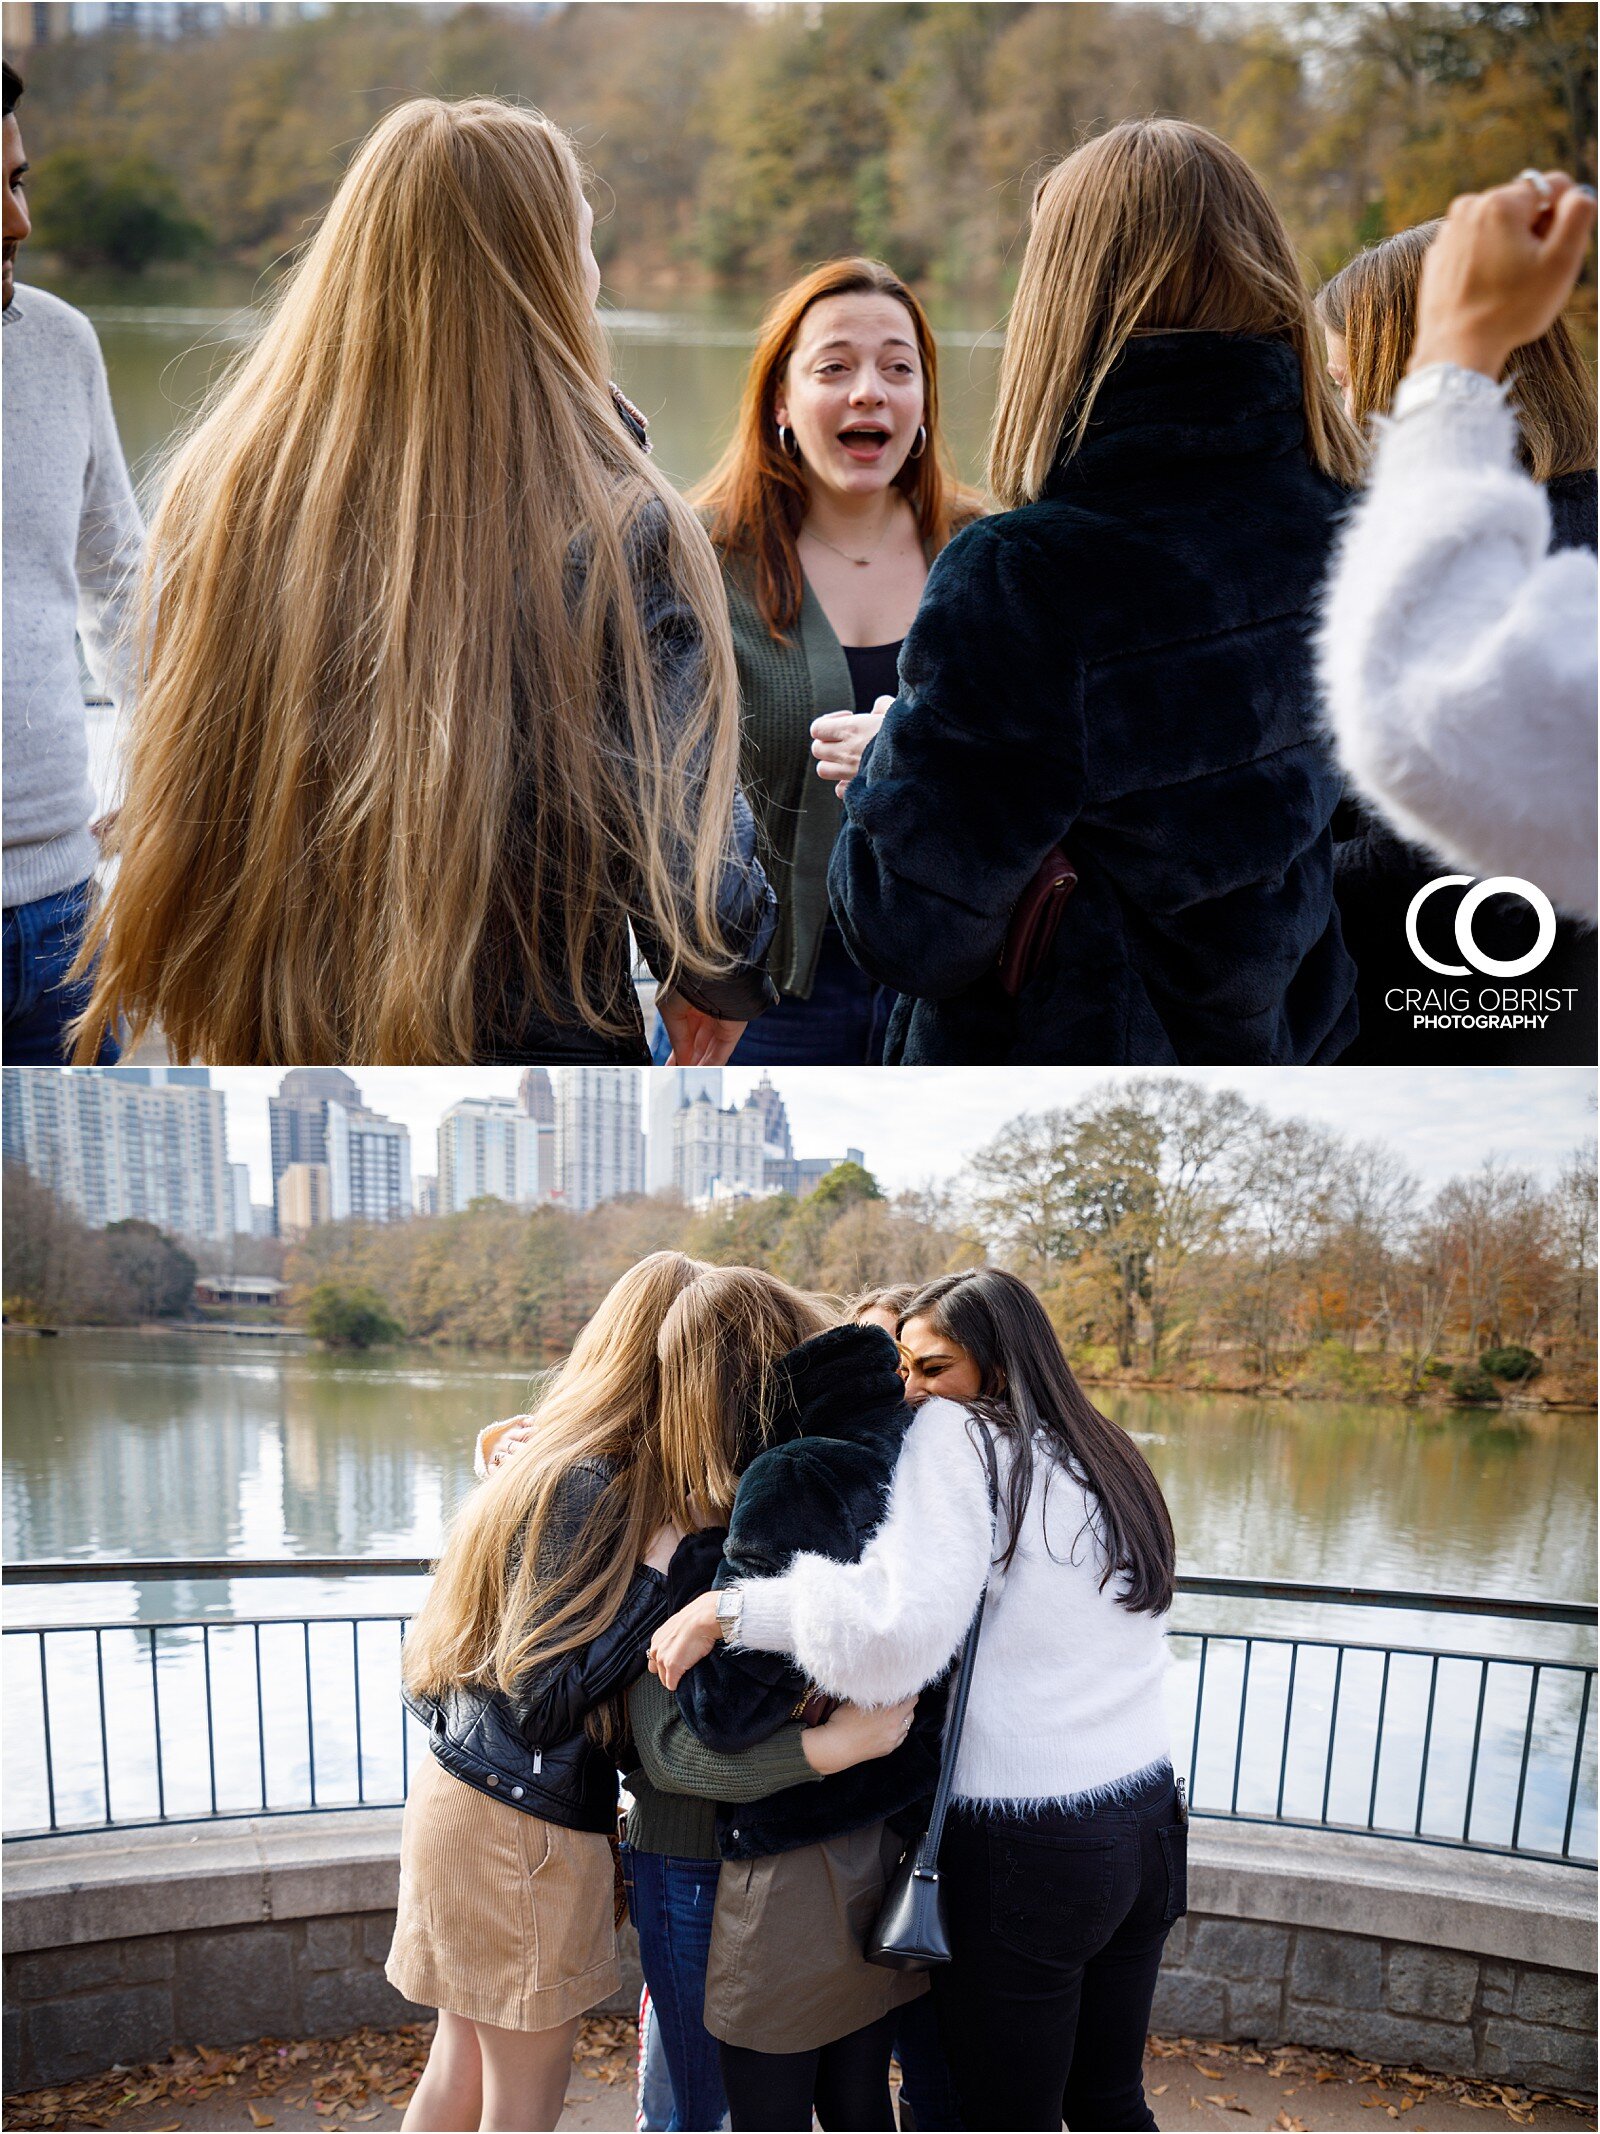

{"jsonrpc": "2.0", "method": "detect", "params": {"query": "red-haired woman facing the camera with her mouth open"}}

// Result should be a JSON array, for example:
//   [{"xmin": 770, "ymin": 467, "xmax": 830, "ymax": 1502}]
[{"xmin": 657, "ymin": 258, "xmax": 981, "ymax": 1065}]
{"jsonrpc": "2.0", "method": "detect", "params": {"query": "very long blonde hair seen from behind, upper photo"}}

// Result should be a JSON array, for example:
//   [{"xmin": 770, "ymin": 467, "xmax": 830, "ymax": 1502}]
[{"xmin": 77, "ymin": 96, "xmax": 738, "ymax": 1063}]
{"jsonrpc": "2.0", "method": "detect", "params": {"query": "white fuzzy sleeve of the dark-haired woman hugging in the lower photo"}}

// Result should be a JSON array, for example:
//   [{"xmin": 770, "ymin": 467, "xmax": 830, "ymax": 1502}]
[{"xmin": 738, "ymin": 1400, "xmax": 994, "ymax": 1705}]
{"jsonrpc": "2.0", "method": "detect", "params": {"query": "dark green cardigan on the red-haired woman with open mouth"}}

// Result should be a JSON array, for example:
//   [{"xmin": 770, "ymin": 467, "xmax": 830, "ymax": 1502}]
[{"xmin": 723, "ymin": 557, "xmax": 855, "ymax": 1001}]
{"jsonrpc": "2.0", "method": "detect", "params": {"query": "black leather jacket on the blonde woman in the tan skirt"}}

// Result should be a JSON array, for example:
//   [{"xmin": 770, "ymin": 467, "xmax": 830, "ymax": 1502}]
[{"xmin": 405, "ymin": 1460, "xmax": 668, "ymax": 1831}]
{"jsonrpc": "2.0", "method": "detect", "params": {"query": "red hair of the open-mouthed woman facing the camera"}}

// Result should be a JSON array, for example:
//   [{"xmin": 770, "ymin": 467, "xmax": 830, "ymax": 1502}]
[{"xmin": 689, "ymin": 258, "xmax": 983, "ymax": 638}]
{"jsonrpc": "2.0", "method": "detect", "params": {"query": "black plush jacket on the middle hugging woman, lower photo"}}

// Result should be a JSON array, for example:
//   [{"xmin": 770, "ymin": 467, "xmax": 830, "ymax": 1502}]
[{"xmin": 668, "ymin": 1327, "xmax": 945, "ymax": 1859}]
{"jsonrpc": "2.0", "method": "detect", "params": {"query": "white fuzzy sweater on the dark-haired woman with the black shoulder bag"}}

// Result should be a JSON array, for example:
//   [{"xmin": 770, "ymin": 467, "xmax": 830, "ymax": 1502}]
[{"xmin": 738, "ymin": 1400, "xmax": 1169, "ymax": 1805}]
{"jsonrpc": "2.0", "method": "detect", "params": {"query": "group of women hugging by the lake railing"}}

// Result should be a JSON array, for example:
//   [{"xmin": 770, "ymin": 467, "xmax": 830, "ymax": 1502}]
[{"xmin": 388, "ymin": 1253, "xmax": 1188, "ymax": 2134}]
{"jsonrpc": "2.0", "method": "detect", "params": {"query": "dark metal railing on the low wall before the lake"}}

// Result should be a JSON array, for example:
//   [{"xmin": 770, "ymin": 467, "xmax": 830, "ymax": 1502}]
[{"xmin": 4, "ymin": 1556, "xmax": 1598, "ymax": 1867}]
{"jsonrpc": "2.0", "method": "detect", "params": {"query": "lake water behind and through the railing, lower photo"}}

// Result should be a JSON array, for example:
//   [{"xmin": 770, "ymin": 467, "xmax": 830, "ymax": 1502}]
[{"xmin": 4, "ymin": 1332, "xmax": 1596, "ymax": 1852}]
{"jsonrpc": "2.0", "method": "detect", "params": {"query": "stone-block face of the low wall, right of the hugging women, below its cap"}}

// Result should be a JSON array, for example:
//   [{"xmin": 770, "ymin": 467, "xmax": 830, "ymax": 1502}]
[{"xmin": 1152, "ymin": 1912, "xmax": 1596, "ymax": 2096}]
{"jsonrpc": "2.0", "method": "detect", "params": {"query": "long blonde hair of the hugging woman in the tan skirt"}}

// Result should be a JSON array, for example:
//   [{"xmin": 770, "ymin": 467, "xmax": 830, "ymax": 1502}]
[{"xmin": 401, "ymin": 1253, "xmax": 710, "ymax": 1697}]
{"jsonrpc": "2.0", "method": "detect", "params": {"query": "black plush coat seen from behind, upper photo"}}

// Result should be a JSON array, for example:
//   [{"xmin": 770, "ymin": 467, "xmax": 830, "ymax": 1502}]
[{"xmin": 828, "ymin": 333, "xmax": 1355, "ymax": 1065}]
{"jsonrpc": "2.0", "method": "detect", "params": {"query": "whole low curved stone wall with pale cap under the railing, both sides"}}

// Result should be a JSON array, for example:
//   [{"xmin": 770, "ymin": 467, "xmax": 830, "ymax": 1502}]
[{"xmin": 4, "ymin": 1810, "xmax": 1596, "ymax": 2096}]
